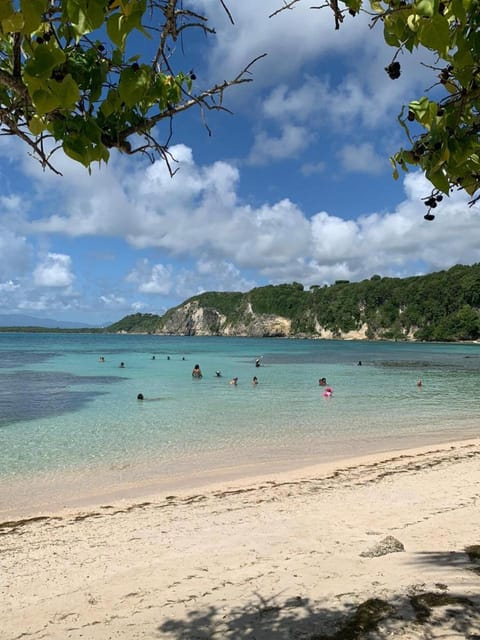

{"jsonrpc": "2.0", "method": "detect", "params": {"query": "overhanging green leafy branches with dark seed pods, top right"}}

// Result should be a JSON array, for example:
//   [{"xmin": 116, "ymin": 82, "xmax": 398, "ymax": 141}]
[{"xmin": 271, "ymin": 0, "xmax": 480, "ymax": 220}]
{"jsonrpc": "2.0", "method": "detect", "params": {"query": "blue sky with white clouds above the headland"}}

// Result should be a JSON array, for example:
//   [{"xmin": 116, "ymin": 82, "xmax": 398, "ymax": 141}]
[{"xmin": 0, "ymin": 0, "xmax": 480, "ymax": 326}]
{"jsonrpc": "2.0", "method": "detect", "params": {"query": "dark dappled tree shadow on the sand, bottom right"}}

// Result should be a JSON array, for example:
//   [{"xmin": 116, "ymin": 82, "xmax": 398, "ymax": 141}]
[{"xmin": 157, "ymin": 545, "xmax": 480, "ymax": 640}]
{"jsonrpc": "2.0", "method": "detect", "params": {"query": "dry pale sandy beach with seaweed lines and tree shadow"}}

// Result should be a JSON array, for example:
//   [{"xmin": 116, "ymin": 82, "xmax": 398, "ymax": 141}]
[{"xmin": 0, "ymin": 440, "xmax": 480, "ymax": 640}]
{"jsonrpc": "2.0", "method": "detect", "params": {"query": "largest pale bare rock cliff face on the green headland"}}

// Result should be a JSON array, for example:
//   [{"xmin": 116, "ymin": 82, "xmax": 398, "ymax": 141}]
[{"xmin": 155, "ymin": 300, "xmax": 291, "ymax": 337}]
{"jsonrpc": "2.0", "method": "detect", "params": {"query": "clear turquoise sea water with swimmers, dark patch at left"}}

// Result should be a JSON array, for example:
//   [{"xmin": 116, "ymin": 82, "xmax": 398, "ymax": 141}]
[{"xmin": 0, "ymin": 333, "xmax": 480, "ymax": 488}]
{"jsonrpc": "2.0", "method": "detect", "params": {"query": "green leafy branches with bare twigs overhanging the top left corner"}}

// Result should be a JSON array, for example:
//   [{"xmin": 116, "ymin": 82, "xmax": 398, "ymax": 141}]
[{"xmin": 0, "ymin": 0, "xmax": 262, "ymax": 170}]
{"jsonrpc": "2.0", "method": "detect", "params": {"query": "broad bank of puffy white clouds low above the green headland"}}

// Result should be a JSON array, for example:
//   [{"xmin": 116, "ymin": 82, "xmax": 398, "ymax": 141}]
[{"xmin": 23, "ymin": 146, "xmax": 480, "ymax": 296}]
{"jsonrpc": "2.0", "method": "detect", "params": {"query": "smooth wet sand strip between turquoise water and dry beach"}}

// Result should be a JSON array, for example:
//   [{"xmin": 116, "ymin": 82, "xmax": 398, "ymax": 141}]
[{"xmin": 0, "ymin": 423, "xmax": 480, "ymax": 523}]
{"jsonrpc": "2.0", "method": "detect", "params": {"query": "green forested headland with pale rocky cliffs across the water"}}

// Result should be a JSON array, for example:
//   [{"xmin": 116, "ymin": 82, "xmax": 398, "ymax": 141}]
[{"xmin": 106, "ymin": 263, "xmax": 480, "ymax": 341}]
